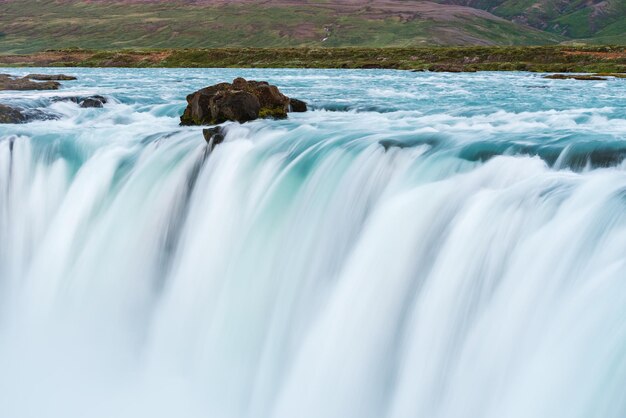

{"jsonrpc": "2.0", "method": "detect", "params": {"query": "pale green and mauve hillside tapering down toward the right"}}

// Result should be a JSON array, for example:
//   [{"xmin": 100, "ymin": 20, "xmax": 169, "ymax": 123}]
[{"xmin": 0, "ymin": 0, "xmax": 563, "ymax": 53}]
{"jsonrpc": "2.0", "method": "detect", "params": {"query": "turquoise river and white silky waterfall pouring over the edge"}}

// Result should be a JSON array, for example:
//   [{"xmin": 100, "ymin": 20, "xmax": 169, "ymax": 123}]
[{"xmin": 0, "ymin": 69, "xmax": 626, "ymax": 418}]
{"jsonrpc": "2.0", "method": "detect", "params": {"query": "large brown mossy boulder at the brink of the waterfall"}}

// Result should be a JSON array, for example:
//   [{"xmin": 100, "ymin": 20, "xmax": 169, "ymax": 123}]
[{"xmin": 180, "ymin": 77, "xmax": 306, "ymax": 125}]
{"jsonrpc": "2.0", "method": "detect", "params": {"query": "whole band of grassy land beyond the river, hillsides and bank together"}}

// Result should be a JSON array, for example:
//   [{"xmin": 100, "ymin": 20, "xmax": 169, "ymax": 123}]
[{"xmin": 0, "ymin": 0, "xmax": 626, "ymax": 73}]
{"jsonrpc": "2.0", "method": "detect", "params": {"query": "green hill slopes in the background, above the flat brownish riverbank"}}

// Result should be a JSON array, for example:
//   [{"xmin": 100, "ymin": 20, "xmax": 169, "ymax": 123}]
[{"xmin": 0, "ymin": 0, "xmax": 626, "ymax": 53}]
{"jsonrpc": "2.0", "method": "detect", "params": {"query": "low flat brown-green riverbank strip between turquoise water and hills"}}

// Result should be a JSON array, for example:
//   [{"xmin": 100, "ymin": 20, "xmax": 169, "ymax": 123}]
[{"xmin": 0, "ymin": 46, "xmax": 626, "ymax": 73}]
